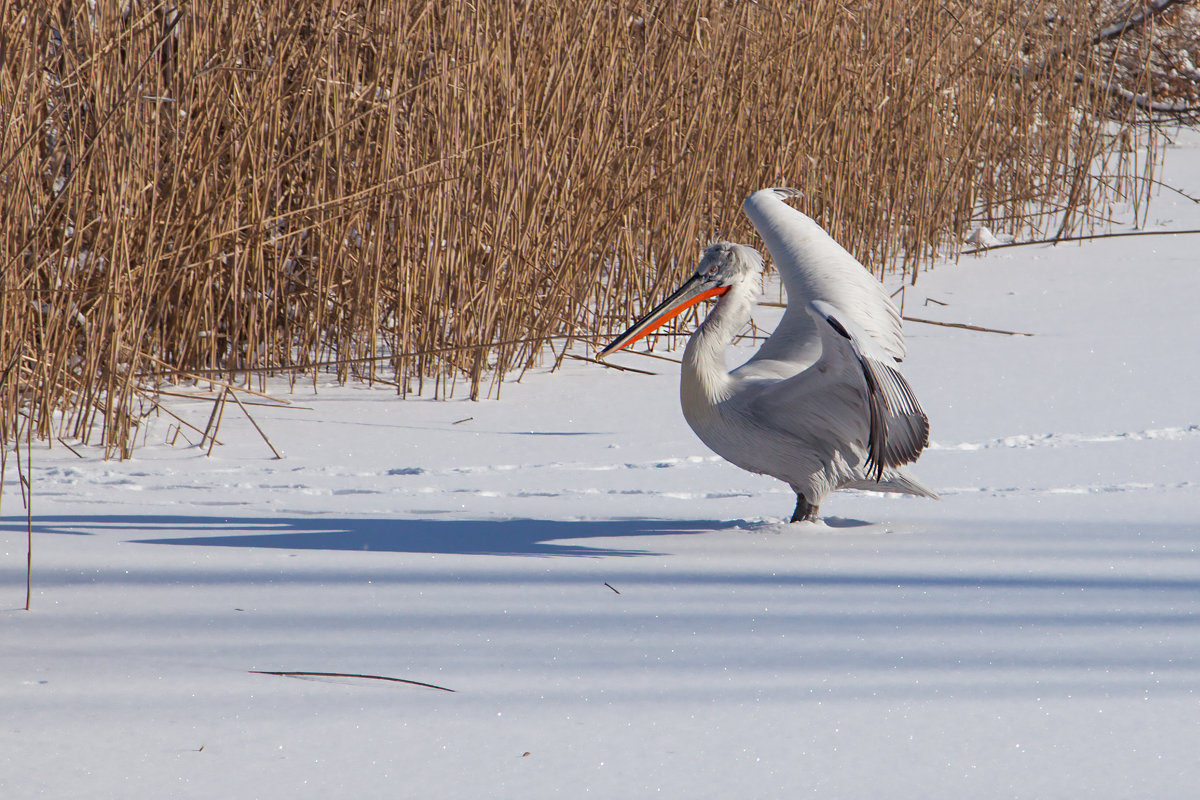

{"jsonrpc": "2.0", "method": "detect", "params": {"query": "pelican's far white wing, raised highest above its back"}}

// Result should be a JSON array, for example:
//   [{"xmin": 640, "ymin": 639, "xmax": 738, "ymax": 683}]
[{"xmin": 742, "ymin": 188, "xmax": 905, "ymax": 363}]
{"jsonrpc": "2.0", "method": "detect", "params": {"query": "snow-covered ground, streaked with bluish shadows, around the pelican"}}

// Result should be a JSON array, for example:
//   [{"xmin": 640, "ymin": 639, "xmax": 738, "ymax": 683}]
[{"xmin": 7, "ymin": 136, "xmax": 1200, "ymax": 799}]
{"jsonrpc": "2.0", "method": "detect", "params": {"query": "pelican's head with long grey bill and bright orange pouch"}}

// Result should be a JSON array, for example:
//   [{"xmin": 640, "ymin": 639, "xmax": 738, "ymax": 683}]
[{"xmin": 598, "ymin": 241, "xmax": 762, "ymax": 359}]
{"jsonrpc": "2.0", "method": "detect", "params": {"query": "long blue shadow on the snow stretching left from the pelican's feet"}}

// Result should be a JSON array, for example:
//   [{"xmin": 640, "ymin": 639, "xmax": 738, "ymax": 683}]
[{"xmin": 0, "ymin": 515, "xmax": 740, "ymax": 557}]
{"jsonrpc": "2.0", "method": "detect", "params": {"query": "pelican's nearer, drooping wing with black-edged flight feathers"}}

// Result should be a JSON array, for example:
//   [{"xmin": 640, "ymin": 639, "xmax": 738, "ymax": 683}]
[{"xmin": 808, "ymin": 300, "xmax": 929, "ymax": 481}]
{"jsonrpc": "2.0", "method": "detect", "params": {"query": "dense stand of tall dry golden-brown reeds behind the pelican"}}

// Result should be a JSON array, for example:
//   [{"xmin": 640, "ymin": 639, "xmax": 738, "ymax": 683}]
[{"xmin": 0, "ymin": 0, "xmax": 1180, "ymax": 456}]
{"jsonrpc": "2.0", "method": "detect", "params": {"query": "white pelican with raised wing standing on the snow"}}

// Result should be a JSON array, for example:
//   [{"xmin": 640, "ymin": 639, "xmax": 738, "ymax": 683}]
[{"xmin": 599, "ymin": 188, "xmax": 937, "ymax": 522}]
